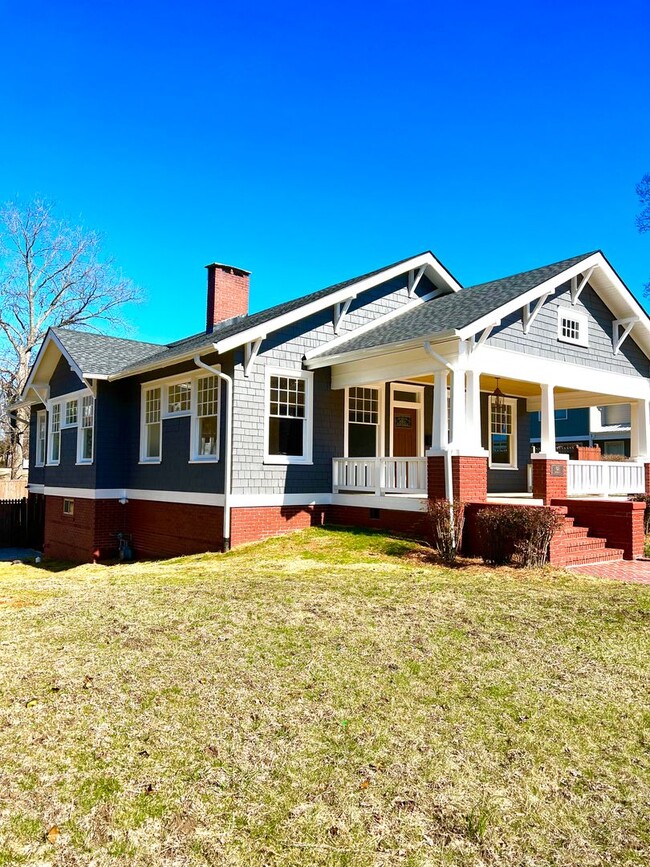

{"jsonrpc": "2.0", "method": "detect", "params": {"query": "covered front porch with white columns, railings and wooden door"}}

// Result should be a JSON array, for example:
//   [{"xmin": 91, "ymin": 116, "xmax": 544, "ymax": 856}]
[{"xmin": 332, "ymin": 369, "xmax": 649, "ymax": 507}]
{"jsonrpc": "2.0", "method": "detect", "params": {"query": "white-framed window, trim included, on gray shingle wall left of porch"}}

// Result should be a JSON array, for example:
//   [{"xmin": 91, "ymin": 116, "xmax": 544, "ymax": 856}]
[{"xmin": 265, "ymin": 370, "xmax": 312, "ymax": 464}]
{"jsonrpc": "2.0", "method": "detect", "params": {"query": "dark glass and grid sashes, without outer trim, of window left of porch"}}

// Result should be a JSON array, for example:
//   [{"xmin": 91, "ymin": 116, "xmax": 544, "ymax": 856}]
[{"xmin": 268, "ymin": 376, "xmax": 307, "ymax": 457}]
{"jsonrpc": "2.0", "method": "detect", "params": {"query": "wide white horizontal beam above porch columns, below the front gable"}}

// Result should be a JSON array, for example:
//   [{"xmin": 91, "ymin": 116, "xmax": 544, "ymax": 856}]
[{"xmin": 468, "ymin": 346, "xmax": 650, "ymax": 403}]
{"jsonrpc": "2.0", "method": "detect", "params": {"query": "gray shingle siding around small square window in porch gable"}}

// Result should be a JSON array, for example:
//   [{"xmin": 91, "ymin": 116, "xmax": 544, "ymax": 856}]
[{"xmin": 486, "ymin": 283, "xmax": 650, "ymax": 376}]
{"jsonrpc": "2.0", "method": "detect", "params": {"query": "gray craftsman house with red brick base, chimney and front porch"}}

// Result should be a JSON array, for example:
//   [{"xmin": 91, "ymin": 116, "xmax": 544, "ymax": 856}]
[{"xmin": 17, "ymin": 252, "xmax": 650, "ymax": 560}]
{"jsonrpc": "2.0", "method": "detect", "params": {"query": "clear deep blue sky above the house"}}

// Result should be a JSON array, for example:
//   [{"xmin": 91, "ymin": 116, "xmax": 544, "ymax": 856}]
[{"xmin": 0, "ymin": 0, "xmax": 650, "ymax": 341}]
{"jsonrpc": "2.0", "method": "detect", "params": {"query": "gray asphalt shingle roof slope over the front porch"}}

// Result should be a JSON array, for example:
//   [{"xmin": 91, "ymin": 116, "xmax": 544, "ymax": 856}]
[{"xmin": 317, "ymin": 253, "xmax": 593, "ymax": 358}]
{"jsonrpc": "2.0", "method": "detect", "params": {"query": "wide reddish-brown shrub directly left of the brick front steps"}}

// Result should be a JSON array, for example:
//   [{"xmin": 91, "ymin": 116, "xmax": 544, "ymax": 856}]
[{"xmin": 476, "ymin": 506, "xmax": 563, "ymax": 566}]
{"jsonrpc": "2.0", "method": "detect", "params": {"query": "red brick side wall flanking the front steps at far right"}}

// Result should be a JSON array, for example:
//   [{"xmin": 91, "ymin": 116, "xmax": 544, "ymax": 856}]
[{"xmin": 552, "ymin": 499, "xmax": 645, "ymax": 560}]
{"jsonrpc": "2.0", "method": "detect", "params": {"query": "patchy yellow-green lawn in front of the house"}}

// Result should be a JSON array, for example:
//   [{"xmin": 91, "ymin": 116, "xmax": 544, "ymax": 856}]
[{"xmin": 0, "ymin": 530, "xmax": 650, "ymax": 867}]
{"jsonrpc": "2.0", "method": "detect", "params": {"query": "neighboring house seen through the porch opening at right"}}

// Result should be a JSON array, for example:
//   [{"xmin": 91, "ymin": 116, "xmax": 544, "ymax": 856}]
[{"xmin": 530, "ymin": 403, "xmax": 632, "ymax": 458}]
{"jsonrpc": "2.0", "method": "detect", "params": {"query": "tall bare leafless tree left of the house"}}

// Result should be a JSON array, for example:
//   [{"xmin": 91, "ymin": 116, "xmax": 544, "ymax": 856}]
[{"xmin": 0, "ymin": 200, "xmax": 139, "ymax": 478}]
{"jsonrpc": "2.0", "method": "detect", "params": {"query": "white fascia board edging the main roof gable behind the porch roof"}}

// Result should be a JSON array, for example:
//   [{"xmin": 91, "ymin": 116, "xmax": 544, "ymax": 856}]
[{"xmin": 214, "ymin": 253, "xmax": 461, "ymax": 353}]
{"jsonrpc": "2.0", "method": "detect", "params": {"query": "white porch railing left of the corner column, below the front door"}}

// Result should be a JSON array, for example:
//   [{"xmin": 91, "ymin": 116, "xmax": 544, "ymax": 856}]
[{"xmin": 332, "ymin": 458, "xmax": 427, "ymax": 496}]
